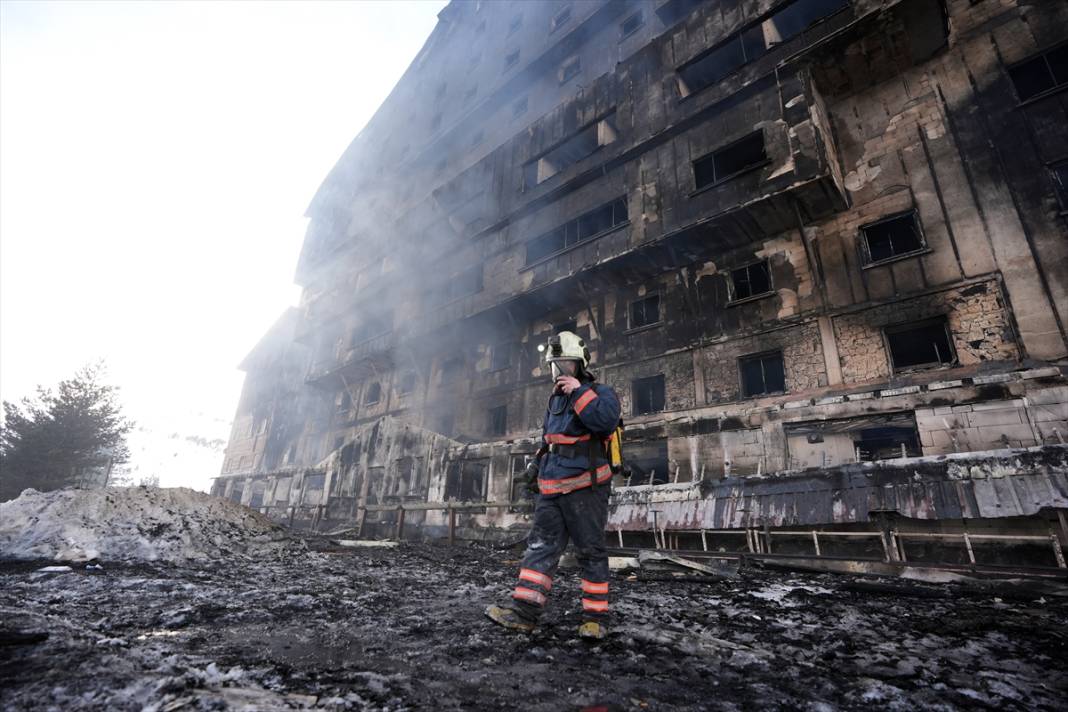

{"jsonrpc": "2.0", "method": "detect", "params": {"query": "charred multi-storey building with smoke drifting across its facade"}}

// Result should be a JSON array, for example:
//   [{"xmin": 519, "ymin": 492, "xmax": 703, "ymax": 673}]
[{"xmin": 216, "ymin": 0, "xmax": 1068, "ymax": 561}]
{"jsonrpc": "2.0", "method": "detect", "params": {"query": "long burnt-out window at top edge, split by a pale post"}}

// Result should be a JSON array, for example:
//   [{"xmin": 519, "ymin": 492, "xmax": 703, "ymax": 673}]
[{"xmin": 674, "ymin": 0, "xmax": 849, "ymax": 97}]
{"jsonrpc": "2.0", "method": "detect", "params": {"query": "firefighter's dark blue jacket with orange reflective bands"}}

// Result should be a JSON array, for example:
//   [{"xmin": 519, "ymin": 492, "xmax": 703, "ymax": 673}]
[{"xmin": 538, "ymin": 382, "xmax": 619, "ymax": 496}]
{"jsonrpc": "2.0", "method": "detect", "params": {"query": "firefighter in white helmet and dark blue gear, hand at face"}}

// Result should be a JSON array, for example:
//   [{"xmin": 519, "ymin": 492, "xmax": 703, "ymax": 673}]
[{"xmin": 486, "ymin": 331, "xmax": 619, "ymax": 639}]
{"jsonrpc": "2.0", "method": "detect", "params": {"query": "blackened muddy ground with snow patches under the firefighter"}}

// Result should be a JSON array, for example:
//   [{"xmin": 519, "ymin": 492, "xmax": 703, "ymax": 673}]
[{"xmin": 0, "ymin": 544, "xmax": 1068, "ymax": 711}]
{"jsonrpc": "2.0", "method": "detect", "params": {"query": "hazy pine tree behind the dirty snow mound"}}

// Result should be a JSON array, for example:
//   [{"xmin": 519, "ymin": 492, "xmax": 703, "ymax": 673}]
[{"xmin": 0, "ymin": 363, "xmax": 134, "ymax": 500}]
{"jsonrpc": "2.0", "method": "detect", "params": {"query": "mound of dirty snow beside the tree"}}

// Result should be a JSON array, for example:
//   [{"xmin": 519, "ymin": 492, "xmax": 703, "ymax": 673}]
[{"xmin": 0, "ymin": 487, "xmax": 302, "ymax": 563}]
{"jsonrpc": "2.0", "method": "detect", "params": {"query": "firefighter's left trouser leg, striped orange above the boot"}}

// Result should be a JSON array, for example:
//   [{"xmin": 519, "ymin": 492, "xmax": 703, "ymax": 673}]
[{"xmin": 512, "ymin": 496, "xmax": 568, "ymax": 620}]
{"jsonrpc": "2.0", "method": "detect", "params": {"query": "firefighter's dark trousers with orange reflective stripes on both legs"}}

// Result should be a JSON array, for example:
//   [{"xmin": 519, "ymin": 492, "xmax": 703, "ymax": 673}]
[{"xmin": 513, "ymin": 485, "xmax": 611, "ymax": 620}]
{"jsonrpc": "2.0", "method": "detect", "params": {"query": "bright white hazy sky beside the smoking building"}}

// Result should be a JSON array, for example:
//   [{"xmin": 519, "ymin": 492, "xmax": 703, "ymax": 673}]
[{"xmin": 0, "ymin": 0, "xmax": 445, "ymax": 484}]
